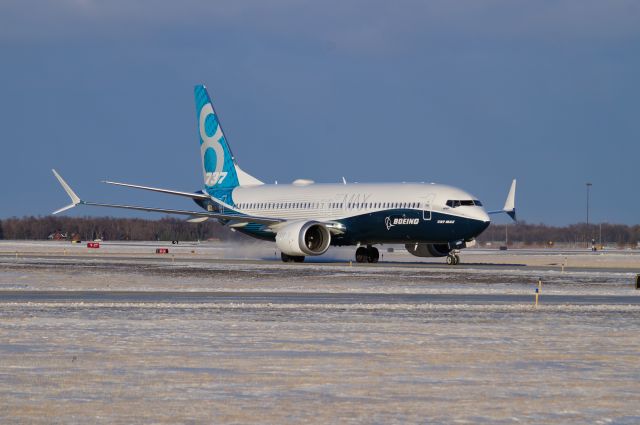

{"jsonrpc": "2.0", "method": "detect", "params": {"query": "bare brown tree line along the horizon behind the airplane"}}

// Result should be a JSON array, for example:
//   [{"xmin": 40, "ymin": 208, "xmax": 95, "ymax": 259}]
[{"xmin": 0, "ymin": 216, "xmax": 640, "ymax": 247}]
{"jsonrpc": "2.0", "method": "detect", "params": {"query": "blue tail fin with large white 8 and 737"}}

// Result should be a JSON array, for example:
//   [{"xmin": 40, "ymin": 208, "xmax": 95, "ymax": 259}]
[{"xmin": 195, "ymin": 85, "xmax": 240, "ymax": 190}]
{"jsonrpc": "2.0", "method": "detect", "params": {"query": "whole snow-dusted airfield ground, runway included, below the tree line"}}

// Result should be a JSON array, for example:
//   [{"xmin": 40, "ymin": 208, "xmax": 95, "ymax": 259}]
[{"xmin": 0, "ymin": 243, "xmax": 640, "ymax": 424}]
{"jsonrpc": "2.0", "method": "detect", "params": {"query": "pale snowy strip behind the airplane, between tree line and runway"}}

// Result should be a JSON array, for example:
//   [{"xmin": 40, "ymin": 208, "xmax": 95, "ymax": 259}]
[{"xmin": 0, "ymin": 240, "xmax": 640, "ymax": 271}]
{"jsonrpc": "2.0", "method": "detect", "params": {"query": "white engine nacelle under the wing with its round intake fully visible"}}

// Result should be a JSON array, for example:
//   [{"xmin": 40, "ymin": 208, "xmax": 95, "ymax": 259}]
[{"xmin": 276, "ymin": 221, "xmax": 331, "ymax": 255}]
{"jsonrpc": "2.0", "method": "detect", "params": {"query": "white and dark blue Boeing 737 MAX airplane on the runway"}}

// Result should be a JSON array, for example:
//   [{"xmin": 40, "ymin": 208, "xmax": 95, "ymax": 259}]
[{"xmin": 52, "ymin": 85, "xmax": 516, "ymax": 265}]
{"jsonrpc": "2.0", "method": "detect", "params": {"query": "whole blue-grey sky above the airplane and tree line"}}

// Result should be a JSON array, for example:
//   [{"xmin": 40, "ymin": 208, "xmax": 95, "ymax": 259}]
[{"xmin": 0, "ymin": 0, "xmax": 640, "ymax": 225}]
